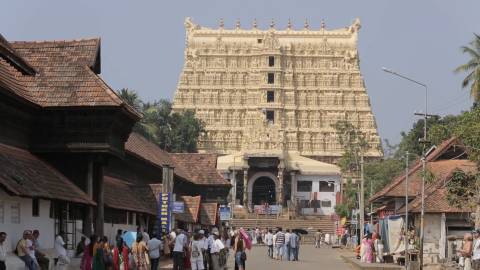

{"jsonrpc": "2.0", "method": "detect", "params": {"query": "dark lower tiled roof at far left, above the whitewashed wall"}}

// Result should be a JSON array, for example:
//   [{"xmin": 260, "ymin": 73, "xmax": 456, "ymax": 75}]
[{"xmin": 0, "ymin": 144, "xmax": 95, "ymax": 205}]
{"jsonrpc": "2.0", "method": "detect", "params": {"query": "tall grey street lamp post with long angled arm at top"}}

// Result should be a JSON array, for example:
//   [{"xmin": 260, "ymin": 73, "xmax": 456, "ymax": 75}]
[{"xmin": 382, "ymin": 67, "xmax": 428, "ymax": 269}]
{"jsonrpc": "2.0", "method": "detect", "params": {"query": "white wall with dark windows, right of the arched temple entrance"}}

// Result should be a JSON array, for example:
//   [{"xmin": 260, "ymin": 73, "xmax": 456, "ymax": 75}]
[{"xmin": 295, "ymin": 175, "xmax": 340, "ymax": 215}]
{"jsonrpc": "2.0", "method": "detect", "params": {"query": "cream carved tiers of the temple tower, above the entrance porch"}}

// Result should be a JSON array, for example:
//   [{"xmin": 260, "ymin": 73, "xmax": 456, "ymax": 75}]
[{"xmin": 173, "ymin": 18, "xmax": 382, "ymax": 160}]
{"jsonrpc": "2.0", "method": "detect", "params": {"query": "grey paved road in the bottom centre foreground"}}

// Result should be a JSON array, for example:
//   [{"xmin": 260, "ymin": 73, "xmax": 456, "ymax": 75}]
[{"xmin": 228, "ymin": 245, "xmax": 353, "ymax": 270}]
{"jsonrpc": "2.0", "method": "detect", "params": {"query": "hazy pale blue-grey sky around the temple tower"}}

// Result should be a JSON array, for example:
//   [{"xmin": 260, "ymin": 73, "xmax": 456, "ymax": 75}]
[{"xmin": 0, "ymin": 0, "xmax": 480, "ymax": 143}]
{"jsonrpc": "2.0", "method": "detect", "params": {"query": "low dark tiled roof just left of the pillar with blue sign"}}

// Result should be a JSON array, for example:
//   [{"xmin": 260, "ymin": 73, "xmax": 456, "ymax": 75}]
[{"xmin": 103, "ymin": 175, "xmax": 157, "ymax": 215}]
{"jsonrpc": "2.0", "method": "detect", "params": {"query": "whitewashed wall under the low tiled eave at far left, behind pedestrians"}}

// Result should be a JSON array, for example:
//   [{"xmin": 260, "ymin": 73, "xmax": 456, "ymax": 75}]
[{"xmin": 0, "ymin": 190, "xmax": 55, "ymax": 251}]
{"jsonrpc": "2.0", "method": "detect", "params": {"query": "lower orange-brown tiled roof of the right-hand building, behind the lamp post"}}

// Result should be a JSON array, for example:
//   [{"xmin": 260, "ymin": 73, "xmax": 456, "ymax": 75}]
[{"xmin": 398, "ymin": 160, "xmax": 477, "ymax": 213}]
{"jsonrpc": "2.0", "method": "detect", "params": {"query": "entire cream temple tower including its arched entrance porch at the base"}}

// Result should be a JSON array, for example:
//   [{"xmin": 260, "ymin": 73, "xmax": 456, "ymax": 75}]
[{"xmin": 173, "ymin": 18, "xmax": 383, "ymax": 214}]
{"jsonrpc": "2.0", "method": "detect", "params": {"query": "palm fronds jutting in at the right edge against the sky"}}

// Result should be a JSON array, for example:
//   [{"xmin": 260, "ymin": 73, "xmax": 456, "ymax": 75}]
[{"xmin": 455, "ymin": 34, "xmax": 480, "ymax": 103}]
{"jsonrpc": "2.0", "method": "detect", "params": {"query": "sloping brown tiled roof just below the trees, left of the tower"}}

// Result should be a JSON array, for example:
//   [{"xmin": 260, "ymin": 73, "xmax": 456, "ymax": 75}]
[{"xmin": 125, "ymin": 132, "xmax": 173, "ymax": 167}]
